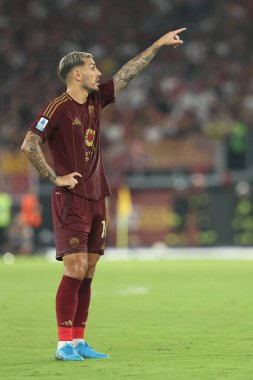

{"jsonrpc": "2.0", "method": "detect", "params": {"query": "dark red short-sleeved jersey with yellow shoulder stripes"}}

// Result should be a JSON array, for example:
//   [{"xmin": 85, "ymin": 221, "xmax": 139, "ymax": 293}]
[{"xmin": 30, "ymin": 79, "xmax": 114, "ymax": 200}]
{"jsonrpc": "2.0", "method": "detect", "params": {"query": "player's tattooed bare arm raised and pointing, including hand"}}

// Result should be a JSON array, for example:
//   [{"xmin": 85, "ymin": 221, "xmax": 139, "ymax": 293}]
[{"xmin": 113, "ymin": 28, "xmax": 186, "ymax": 96}]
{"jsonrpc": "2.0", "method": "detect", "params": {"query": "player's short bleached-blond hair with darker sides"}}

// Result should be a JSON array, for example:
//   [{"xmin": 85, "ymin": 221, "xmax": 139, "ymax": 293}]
[{"xmin": 58, "ymin": 51, "xmax": 93, "ymax": 82}]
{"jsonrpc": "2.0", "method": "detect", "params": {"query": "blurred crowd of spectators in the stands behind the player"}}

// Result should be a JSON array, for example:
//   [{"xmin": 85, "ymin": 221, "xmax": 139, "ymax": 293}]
[{"xmin": 0, "ymin": 0, "xmax": 253, "ymax": 183}]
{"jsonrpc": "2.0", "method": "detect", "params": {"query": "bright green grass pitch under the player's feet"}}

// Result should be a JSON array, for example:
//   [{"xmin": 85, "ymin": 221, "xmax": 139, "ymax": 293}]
[{"xmin": 0, "ymin": 258, "xmax": 253, "ymax": 380}]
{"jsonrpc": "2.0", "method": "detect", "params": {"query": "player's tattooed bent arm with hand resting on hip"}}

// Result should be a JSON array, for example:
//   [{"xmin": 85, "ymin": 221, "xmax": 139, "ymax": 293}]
[{"xmin": 21, "ymin": 131, "xmax": 82, "ymax": 189}]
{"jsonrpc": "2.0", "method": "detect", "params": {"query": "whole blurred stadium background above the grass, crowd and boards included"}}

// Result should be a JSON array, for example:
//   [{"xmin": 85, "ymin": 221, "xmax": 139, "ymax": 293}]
[{"xmin": 0, "ymin": 0, "xmax": 253, "ymax": 255}]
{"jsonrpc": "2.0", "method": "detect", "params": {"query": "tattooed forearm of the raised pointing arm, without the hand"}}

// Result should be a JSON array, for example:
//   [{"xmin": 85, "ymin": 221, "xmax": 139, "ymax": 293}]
[{"xmin": 113, "ymin": 43, "xmax": 160, "ymax": 95}]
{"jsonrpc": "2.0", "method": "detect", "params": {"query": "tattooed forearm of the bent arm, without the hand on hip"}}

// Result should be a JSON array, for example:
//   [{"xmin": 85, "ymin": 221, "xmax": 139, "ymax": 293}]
[{"xmin": 23, "ymin": 132, "xmax": 57, "ymax": 183}]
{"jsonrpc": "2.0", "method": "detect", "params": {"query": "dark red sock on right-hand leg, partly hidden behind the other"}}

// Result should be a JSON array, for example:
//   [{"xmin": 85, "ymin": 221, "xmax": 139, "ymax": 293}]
[{"xmin": 73, "ymin": 278, "xmax": 92, "ymax": 339}]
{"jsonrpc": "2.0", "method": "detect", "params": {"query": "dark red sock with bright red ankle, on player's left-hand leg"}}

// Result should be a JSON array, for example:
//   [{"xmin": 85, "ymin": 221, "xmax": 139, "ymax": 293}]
[{"xmin": 56, "ymin": 276, "xmax": 82, "ymax": 341}]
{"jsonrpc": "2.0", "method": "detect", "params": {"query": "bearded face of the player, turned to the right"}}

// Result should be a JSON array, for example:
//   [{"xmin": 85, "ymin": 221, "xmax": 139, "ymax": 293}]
[{"xmin": 78, "ymin": 58, "xmax": 101, "ymax": 93}]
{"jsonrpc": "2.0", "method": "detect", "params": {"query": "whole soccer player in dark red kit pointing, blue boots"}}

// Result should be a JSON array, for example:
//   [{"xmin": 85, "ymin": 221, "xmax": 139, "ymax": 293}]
[{"xmin": 21, "ymin": 28, "xmax": 186, "ymax": 361}]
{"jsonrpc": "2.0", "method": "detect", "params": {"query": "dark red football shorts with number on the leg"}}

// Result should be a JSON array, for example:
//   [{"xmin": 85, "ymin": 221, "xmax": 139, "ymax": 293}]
[{"xmin": 52, "ymin": 188, "xmax": 106, "ymax": 260}]
